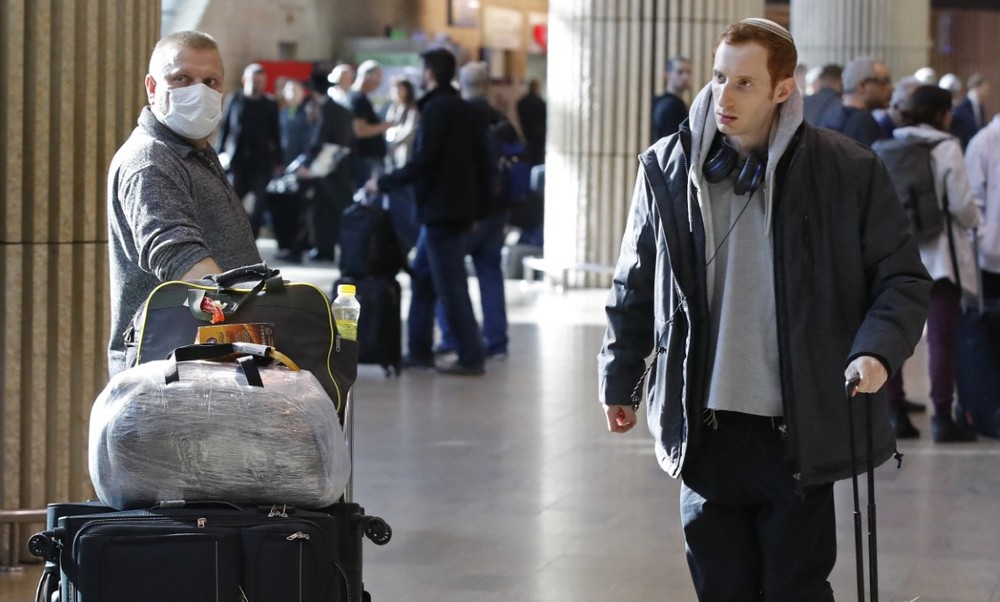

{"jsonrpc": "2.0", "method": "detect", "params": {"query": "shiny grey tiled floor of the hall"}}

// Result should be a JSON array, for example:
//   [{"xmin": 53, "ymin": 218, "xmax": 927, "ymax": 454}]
[{"xmin": 0, "ymin": 245, "xmax": 1000, "ymax": 602}]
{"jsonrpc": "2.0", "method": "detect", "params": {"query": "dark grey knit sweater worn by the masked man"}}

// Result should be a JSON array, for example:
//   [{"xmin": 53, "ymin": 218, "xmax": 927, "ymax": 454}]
[{"xmin": 108, "ymin": 107, "xmax": 261, "ymax": 375}]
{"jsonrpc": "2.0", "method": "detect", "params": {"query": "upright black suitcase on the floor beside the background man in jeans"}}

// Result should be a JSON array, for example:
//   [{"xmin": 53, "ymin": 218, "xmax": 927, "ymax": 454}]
[{"xmin": 333, "ymin": 276, "xmax": 403, "ymax": 376}]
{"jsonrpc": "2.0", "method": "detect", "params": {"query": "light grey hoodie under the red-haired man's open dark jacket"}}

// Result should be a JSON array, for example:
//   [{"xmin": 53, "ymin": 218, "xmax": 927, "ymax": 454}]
[{"xmin": 690, "ymin": 84, "xmax": 802, "ymax": 416}]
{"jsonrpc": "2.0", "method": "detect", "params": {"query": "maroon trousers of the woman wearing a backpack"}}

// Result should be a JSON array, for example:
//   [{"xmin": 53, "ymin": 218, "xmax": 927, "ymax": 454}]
[{"xmin": 885, "ymin": 279, "xmax": 962, "ymax": 416}]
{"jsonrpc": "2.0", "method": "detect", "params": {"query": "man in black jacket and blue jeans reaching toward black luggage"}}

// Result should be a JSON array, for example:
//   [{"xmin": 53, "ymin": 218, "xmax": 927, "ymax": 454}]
[{"xmin": 366, "ymin": 48, "xmax": 490, "ymax": 375}]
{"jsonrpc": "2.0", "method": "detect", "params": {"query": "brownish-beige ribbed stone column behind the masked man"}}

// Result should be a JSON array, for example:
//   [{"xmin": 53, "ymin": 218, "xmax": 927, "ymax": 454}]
[{"xmin": 0, "ymin": 0, "xmax": 160, "ymax": 553}]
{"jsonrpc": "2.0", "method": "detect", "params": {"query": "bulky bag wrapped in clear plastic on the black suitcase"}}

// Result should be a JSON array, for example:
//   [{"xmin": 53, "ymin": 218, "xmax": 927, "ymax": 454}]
[{"xmin": 89, "ymin": 344, "xmax": 351, "ymax": 509}]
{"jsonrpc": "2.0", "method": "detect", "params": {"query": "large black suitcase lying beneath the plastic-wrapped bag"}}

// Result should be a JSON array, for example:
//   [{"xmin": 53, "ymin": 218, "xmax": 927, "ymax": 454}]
[{"xmin": 28, "ymin": 502, "xmax": 391, "ymax": 602}]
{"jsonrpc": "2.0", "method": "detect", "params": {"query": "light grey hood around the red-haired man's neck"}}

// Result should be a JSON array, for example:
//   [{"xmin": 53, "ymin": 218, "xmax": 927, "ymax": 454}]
[{"xmin": 688, "ymin": 83, "xmax": 803, "ymax": 243}]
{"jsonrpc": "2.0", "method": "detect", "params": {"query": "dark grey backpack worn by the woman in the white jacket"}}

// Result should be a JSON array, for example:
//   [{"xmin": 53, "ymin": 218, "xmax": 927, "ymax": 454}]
[{"xmin": 872, "ymin": 137, "xmax": 945, "ymax": 242}]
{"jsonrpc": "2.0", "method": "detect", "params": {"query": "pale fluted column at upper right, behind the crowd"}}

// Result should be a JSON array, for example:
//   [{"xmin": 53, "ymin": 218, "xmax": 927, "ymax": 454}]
[{"xmin": 789, "ymin": 0, "xmax": 932, "ymax": 84}]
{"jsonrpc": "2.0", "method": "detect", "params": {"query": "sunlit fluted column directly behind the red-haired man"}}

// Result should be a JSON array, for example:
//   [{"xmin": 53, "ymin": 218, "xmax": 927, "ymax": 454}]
[{"xmin": 545, "ymin": 0, "xmax": 764, "ymax": 286}]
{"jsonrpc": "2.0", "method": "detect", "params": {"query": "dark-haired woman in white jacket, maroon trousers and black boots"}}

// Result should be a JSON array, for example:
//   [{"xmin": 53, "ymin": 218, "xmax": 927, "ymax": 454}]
[{"xmin": 886, "ymin": 85, "xmax": 980, "ymax": 443}]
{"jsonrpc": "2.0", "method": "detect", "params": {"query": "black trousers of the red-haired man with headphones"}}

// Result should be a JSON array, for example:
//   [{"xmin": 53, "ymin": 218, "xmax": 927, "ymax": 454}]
[{"xmin": 681, "ymin": 412, "xmax": 837, "ymax": 602}]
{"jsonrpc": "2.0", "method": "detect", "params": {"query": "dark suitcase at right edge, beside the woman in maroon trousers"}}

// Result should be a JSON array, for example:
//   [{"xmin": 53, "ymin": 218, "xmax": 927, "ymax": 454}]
[{"xmin": 955, "ymin": 304, "xmax": 1000, "ymax": 437}]
